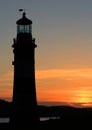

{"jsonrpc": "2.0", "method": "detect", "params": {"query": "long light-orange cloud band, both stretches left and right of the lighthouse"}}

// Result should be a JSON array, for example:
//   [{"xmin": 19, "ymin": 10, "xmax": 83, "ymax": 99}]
[{"xmin": 0, "ymin": 69, "xmax": 92, "ymax": 86}]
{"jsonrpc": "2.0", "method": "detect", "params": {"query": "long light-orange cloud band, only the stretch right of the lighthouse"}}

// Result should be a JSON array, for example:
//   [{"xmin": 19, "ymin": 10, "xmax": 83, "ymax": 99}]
[{"xmin": 36, "ymin": 69, "xmax": 92, "ymax": 80}]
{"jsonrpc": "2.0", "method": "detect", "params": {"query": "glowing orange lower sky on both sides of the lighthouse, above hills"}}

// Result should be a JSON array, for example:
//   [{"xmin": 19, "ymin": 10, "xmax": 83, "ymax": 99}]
[{"xmin": 0, "ymin": 69, "xmax": 92, "ymax": 107}]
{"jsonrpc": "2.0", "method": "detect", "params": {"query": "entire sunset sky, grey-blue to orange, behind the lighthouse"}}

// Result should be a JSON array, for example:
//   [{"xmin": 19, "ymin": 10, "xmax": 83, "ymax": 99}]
[{"xmin": 0, "ymin": 0, "xmax": 92, "ymax": 107}]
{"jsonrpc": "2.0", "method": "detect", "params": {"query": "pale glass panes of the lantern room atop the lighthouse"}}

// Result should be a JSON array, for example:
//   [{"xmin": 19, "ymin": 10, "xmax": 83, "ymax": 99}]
[{"xmin": 17, "ymin": 24, "xmax": 32, "ymax": 34}]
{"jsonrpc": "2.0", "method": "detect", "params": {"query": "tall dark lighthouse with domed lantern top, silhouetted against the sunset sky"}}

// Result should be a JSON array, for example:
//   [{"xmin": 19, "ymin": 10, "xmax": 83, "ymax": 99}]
[{"xmin": 10, "ymin": 11, "xmax": 39, "ymax": 128}]
